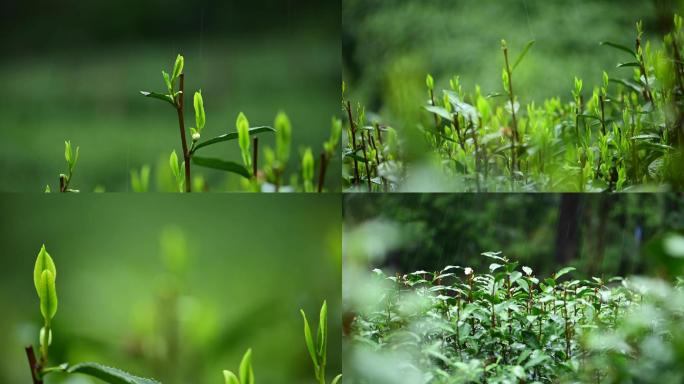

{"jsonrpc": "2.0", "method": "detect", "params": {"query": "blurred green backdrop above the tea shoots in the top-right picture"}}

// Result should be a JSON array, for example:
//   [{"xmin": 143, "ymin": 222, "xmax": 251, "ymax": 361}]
[{"xmin": 342, "ymin": 0, "xmax": 684, "ymax": 126}]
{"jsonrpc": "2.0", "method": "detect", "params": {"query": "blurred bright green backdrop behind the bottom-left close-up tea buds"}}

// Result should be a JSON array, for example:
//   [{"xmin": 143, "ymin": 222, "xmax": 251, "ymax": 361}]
[{"xmin": 0, "ymin": 194, "xmax": 341, "ymax": 384}]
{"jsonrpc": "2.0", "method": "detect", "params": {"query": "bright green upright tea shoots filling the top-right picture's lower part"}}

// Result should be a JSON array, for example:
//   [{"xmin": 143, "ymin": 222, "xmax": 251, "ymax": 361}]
[{"xmin": 343, "ymin": 15, "xmax": 684, "ymax": 192}]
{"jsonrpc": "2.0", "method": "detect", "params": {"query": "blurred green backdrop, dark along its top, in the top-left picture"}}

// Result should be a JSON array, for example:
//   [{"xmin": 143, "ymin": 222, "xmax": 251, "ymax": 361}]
[{"xmin": 0, "ymin": 0, "xmax": 341, "ymax": 192}]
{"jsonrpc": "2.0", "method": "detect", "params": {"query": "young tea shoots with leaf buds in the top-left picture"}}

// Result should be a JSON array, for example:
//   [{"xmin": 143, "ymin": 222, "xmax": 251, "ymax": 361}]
[{"xmin": 46, "ymin": 54, "xmax": 341, "ymax": 192}]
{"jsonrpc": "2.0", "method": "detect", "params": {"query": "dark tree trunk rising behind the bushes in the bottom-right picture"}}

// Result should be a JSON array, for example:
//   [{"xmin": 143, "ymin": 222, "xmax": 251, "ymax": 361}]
[{"xmin": 555, "ymin": 193, "xmax": 584, "ymax": 266}]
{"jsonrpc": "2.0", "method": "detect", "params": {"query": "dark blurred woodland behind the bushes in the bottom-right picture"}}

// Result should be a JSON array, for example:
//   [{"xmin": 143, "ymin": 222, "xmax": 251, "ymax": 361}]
[{"xmin": 344, "ymin": 193, "xmax": 684, "ymax": 277}]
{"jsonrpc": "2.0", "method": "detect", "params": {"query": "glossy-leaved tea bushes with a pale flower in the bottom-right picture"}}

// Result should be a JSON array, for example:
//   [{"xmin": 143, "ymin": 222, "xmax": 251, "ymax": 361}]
[{"xmin": 349, "ymin": 252, "xmax": 682, "ymax": 383}]
